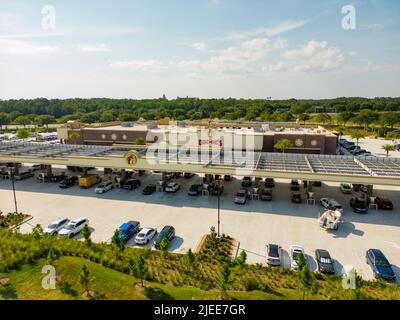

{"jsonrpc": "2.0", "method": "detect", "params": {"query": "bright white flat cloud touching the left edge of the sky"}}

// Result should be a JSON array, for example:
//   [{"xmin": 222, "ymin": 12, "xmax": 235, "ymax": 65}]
[{"xmin": 0, "ymin": 39, "xmax": 60, "ymax": 55}]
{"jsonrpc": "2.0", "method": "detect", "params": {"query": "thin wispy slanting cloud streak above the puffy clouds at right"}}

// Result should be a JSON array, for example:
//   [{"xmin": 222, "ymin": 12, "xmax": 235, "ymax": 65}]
[{"xmin": 224, "ymin": 20, "xmax": 307, "ymax": 40}]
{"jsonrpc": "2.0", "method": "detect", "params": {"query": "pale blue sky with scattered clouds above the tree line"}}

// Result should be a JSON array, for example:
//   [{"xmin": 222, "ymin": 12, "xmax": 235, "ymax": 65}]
[{"xmin": 0, "ymin": 0, "xmax": 400, "ymax": 99}]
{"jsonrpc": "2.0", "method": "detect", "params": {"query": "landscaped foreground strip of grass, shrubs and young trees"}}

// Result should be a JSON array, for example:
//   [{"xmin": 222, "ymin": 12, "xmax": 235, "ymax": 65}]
[{"xmin": 0, "ymin": 227, "xmax": 400, "ymax": 299}]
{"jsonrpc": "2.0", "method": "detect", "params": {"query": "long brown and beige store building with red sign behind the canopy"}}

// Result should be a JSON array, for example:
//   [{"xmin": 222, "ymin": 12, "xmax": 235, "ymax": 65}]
[{"xmin": 58, "ymin": 119, "xmax": 337, "ymax": 154}]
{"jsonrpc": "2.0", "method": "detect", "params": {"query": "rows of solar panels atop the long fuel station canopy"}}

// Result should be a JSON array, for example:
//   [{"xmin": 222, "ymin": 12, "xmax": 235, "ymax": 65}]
[{"xmin": 0, "ymin": 142, "xmax": 400, "ymax": 177}]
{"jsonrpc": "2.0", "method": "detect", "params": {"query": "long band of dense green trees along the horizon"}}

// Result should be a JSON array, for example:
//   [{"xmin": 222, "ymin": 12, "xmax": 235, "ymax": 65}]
[{"xmin": 0, "ymin": 98, "xmax": 400, "ymax": 126}]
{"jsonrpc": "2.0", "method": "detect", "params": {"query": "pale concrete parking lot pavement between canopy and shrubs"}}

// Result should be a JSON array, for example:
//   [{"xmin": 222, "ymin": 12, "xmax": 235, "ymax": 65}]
[{"xmin": 0, "ymin": 168, "xmax": 400, "ymax": 279}]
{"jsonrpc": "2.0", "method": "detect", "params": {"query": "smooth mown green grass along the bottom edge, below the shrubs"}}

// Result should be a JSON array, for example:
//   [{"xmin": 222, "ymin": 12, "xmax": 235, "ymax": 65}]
[{"xmin": 0, "ymin": 257, "xmax": 304, "ymax": 300}]
